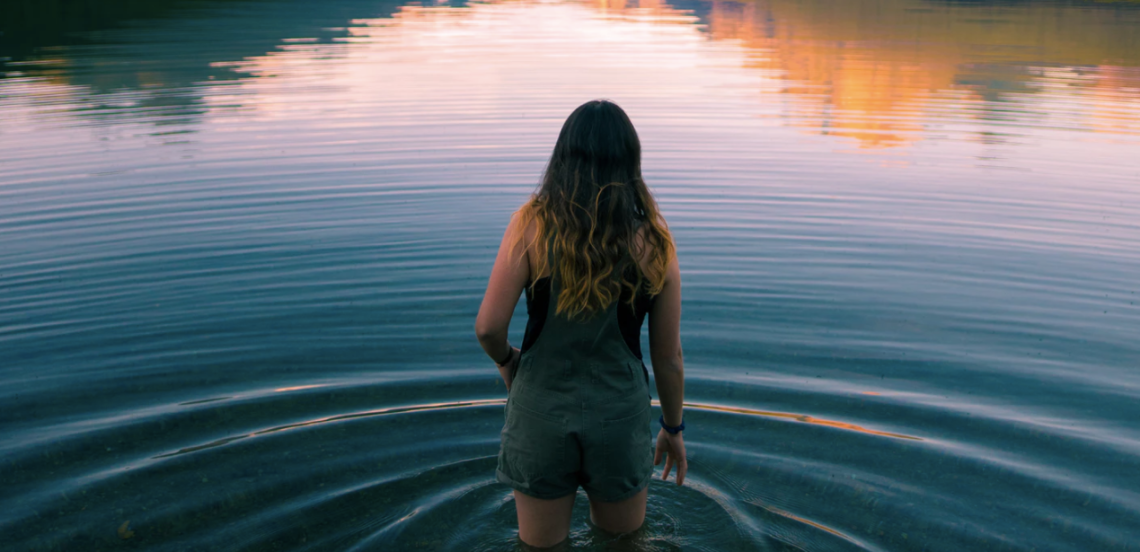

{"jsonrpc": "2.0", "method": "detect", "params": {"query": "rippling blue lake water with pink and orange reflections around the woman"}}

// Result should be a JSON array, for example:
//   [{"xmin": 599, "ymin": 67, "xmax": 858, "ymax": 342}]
[{"xmin": 0, "ymin": 0, "xmax": 1140, "ymax": 552}]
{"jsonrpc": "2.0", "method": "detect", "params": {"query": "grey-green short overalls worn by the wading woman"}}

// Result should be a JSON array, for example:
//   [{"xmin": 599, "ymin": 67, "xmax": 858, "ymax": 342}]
[{"xmin": 496, "ymin": 276, "xmax": 653, "ymax": 502}]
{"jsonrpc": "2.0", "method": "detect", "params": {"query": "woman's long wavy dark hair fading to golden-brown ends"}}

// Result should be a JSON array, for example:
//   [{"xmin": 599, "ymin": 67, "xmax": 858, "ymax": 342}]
[{"xmin": 512, "ymin": 100, "xmax": 675, "ymax": 318}]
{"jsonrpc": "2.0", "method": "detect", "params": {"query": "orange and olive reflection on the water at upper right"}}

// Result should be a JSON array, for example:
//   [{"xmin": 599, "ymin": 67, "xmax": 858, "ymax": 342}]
[{"xmin": 708, "ymin": 0, "xmax": 1140, "ymax": 148}]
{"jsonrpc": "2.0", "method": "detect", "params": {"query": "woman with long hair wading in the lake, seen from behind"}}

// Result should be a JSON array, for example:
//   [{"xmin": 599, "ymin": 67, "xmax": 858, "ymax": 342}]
[{"xmin": 475, "ymin": 100, "xmax": 689, "ymax": 547}]
